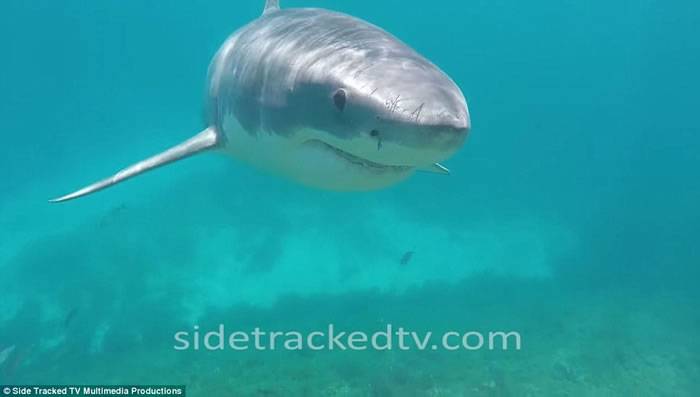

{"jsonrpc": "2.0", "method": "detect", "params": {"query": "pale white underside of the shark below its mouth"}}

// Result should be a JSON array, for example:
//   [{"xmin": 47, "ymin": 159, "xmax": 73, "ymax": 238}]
[{"xmin": 223, "ymin": 117, "xmax": 413, "ymax": 191}]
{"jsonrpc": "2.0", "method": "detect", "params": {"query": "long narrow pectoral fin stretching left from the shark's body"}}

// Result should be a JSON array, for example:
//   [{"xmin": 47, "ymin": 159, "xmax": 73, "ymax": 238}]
[{"xmin": 49, "ymin": 127, "xmax": 221, "ymax": 203}]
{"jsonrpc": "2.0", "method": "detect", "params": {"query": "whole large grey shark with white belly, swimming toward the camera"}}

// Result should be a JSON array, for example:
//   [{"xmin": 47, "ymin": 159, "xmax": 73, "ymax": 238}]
[{"xmin": 51, "ymin": 0, "xmax": 470, "ymax": 202}]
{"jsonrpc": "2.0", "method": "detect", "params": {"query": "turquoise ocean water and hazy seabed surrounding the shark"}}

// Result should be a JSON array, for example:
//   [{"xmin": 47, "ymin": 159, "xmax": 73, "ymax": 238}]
[{"xmin": 0, "ymin": 0, "xmax": 700, "ymax": 397}]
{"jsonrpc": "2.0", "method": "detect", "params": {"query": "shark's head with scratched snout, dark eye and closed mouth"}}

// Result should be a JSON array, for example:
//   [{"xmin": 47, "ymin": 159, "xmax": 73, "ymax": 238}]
[{"xmin": 292, "ymin": 54, "xmax": 470, "ymax": 168}]
